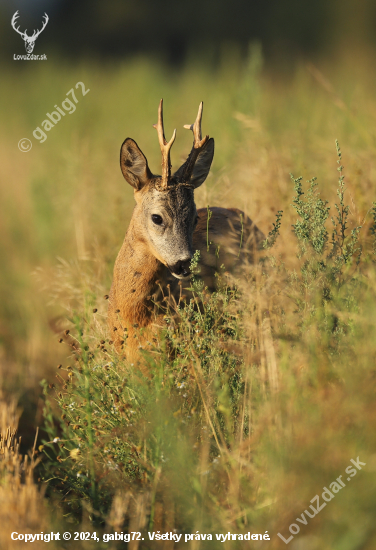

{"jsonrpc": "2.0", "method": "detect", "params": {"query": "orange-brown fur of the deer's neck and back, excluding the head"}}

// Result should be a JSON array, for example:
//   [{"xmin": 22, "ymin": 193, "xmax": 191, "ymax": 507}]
[{"xmin": 108, "ymin": 202, "xmax": 265, "ymax": 361}]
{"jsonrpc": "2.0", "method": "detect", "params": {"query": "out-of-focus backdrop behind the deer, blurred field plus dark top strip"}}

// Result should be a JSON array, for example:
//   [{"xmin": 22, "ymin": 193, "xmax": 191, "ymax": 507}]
[{"xmin": 0, "ymin": 0, "xmax": 376, "ymax": 447}]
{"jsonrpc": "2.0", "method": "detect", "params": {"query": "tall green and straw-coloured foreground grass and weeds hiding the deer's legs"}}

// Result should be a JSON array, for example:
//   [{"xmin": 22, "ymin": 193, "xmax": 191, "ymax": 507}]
[{"xmin": 33, "ymin": 139, "xmax": 375, "ymax": 548}]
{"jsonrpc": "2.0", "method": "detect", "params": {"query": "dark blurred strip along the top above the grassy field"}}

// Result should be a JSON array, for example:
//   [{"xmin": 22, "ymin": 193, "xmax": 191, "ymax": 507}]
[{"xmin": 0, "ymin": 0, "xmax": 376, "ymax": 69}]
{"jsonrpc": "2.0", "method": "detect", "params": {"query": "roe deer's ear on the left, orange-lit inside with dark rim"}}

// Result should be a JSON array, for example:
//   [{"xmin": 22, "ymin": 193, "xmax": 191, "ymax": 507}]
[{"xmin": 120, "ymin": 138, "xmax": 153, "ymax": 191}]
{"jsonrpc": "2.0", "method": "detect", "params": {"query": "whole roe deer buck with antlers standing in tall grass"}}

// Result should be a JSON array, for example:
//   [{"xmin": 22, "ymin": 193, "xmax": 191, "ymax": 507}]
[{"xmin": 108, "ymin": 100, "xmax": 265, "ymax": 360}]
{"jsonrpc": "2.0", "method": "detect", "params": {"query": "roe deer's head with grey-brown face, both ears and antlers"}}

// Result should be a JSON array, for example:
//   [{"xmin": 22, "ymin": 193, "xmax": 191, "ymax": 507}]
[{"xmin": 120, "ymin": 99, "xmax": 214, "ymax": 279}]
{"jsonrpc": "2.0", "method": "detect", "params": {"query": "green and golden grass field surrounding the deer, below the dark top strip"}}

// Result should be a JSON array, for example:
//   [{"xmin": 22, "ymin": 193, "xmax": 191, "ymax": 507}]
[{"xmin": 0, "ymin": 49, "xmax": 376, "ymax": 550}]
